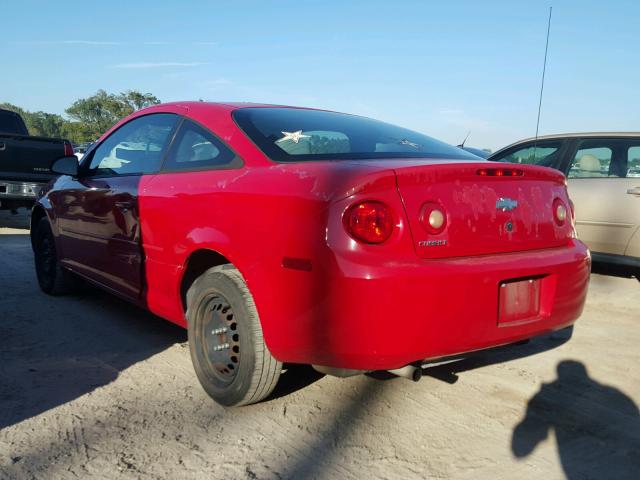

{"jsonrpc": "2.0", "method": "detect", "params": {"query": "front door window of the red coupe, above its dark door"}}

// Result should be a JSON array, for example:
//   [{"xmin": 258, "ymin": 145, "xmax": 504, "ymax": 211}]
[{"xmin": 89, "ymin": 113, "xmax": 179, "ymax": 175}]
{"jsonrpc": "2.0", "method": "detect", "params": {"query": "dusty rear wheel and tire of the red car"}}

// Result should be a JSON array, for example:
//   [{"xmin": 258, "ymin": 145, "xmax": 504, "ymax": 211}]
[{"xmin": 187, "ymin": 265, "xmax": 282, "ymax": 407}]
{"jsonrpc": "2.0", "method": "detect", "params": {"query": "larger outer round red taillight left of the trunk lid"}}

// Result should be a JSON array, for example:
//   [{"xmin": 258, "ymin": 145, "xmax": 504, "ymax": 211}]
[{"xmin": 345, "ymin": 202, "xmax": 394, "ymax": 244}]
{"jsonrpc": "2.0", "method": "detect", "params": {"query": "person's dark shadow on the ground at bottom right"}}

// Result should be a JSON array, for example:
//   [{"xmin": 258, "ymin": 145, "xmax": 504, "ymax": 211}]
[{"xmin": 511, "ymin": 360, "xmax": 640, "ymax": 479}]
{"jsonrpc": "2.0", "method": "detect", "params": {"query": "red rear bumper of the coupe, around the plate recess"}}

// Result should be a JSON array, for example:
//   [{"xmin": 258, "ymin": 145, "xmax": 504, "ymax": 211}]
[{"xmin": 270, "ymin": 240, "xmax": 590, "ymax": 370}]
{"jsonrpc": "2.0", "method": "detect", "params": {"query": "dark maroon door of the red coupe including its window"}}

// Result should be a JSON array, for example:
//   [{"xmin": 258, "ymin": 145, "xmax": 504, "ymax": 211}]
[{"xmin": 54, "ymin": 113, "xmax": 180, "ymax": 299}]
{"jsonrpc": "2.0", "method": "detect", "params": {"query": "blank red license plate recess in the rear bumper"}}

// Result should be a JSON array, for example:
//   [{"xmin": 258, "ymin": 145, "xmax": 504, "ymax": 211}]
[{"xmin": 498, "ymin": 278, "xmax": 541, "ymax": 325}]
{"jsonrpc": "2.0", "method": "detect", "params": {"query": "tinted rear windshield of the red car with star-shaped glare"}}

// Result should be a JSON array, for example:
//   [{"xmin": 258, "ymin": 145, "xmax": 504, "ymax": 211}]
[{"xmin": 233, "ymin": 108, "xmax": 478, "ymax": 162}]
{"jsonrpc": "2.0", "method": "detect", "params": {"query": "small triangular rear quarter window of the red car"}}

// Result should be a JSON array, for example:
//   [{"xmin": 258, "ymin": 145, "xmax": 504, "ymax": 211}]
[{"xmin": 163, "ymin": 120, "xmax": 236, "ymax": 170}]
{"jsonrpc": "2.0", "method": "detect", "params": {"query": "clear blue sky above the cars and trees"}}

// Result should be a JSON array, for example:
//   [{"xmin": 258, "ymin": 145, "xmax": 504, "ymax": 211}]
[{"xmin": 0, "ymin": 0, "xmax": 640, "ymax": 149}]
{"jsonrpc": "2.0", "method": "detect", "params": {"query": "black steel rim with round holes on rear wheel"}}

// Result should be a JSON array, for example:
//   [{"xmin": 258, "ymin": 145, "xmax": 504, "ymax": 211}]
[{"xmin": 201, "ymin": 294, "xmax": 240, "ymax": 384}]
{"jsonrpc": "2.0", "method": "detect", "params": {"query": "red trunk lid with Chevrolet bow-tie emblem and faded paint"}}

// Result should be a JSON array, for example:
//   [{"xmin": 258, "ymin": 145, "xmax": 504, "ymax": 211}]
[{"xmin": 394, "ymin": 162, "xmax": 573, "ymax": 258}]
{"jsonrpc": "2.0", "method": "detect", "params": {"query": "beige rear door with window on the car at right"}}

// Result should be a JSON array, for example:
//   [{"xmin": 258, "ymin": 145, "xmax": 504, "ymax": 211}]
[{"xmin": 567, "ymin": 138, "xmax": 640, "ymax": 255}]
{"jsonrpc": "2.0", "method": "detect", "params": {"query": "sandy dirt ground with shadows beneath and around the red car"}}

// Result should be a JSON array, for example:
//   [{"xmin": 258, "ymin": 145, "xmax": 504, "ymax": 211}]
[{"xmin": 0, "ymin": 212, "xmax": 640, "ymax": 479}]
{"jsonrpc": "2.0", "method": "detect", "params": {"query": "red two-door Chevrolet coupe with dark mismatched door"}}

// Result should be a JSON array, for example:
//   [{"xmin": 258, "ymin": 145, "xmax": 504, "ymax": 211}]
[{"xmin": 31, "ymin": 102, "xmax": 590, "ymax": 405}]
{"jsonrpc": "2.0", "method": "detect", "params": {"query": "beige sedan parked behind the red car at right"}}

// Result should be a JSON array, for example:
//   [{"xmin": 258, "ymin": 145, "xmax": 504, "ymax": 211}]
[{"xmin": 488, "ymin": 133, "xmax": 640, "ymax": 279}]
